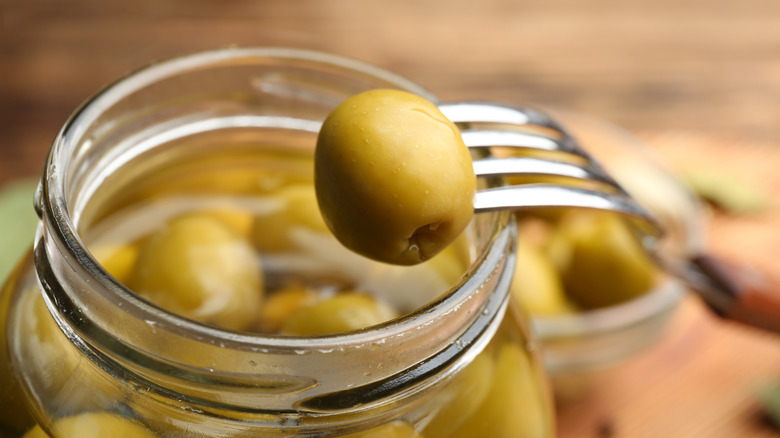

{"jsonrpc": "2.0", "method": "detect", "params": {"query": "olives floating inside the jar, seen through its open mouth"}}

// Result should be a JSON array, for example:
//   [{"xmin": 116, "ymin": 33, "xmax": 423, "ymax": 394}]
[{"xmin": 93, "ymin": 201, "xmax": 444, "ymax": 335}]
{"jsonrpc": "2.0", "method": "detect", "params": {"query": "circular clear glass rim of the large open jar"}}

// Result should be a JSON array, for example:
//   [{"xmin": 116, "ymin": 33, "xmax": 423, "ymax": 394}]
[{"xmin": 36, "ymin": 47, "xmax": 514, "ymax": 349}]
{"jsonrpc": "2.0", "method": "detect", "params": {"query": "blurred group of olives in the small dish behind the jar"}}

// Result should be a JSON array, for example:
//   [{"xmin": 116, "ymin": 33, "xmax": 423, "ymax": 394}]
[{"xmin": 511, "ymin": 210, "xmax": 659, "ymax": 317}]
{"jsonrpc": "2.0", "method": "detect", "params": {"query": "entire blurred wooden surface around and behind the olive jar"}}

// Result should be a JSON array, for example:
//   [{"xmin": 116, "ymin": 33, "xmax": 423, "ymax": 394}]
[{"xmin": 0, "ymin": 0, "xmax": 780, "ymax": 438}]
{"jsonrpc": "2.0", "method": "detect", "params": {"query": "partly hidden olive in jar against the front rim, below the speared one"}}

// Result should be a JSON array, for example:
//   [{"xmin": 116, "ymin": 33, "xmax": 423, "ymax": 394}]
[{"xmin": 282, "ymin": 292, "xmax": 398, "ymax": 336}]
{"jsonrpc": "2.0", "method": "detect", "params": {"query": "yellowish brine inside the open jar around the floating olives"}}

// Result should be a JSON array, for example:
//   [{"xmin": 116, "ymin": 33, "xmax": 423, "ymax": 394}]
[{"xmin": 79, "ymin": 118, "xmax": 473, "ymax": 331}]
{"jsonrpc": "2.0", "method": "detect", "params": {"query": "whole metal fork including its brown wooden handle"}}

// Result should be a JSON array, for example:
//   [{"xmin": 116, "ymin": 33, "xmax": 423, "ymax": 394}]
[{"xmin": 439, "ymin": 102, "xmax": 780, "ymax": 333}]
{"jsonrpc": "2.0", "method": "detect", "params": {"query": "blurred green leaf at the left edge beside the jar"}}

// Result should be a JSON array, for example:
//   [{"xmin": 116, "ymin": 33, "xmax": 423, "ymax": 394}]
[{"xmin": 0, "ymin": 179, "xmax": 38, "ymax": 284}]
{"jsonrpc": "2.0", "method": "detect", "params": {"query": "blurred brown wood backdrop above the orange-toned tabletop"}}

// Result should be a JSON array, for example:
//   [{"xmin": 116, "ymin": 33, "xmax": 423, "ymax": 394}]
[{"xmin": 0, "ymin": 0, "xmax": 780, "ymax": 181}]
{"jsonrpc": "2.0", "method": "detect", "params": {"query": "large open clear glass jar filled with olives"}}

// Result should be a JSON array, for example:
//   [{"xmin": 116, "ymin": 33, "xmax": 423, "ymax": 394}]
[{"xmin": 0, "ymin": 48, "xmax": 554, "ymax": 438}]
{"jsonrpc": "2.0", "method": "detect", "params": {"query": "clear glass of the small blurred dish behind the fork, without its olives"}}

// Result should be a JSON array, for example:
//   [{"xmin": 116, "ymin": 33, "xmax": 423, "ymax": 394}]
[{"xmin": 532, "ymin": 109, "xmax": 704, "ymax": 397}]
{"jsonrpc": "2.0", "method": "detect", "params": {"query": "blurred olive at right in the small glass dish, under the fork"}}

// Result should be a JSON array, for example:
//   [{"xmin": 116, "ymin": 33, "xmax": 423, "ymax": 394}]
[{"xmin": 560, "ymin": 211, "xmax": 658, "ymax": 309}]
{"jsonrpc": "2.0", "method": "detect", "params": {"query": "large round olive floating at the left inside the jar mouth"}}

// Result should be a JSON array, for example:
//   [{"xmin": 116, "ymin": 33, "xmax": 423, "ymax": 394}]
[{"xmin": 129, "ymin": 213, "xmax": 263, "ymax": 330}]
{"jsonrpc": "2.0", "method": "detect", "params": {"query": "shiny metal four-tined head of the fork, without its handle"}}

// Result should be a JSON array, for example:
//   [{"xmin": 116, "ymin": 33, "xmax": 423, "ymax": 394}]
[{"xmin": 439, "ymin": 102, "xmax": 662, "ymax": 240}]
